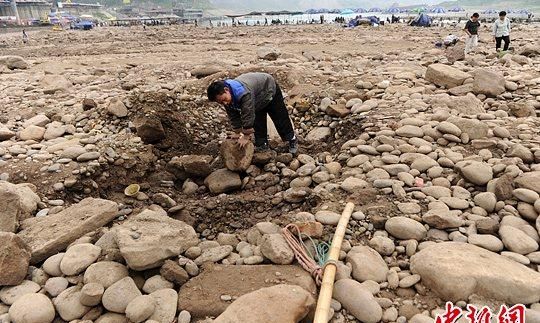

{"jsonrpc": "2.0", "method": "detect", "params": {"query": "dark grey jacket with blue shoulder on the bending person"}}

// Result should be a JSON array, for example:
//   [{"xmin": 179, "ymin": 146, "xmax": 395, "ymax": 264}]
[{"xmin": 225, "ymin": 73, "xmax": 276, "ymax": 129}]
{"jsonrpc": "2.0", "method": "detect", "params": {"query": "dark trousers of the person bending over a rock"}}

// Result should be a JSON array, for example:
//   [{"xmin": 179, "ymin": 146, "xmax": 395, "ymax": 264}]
[{"xmin": 253, "ymin": 84, "xmax": 294, "ymax": 146}]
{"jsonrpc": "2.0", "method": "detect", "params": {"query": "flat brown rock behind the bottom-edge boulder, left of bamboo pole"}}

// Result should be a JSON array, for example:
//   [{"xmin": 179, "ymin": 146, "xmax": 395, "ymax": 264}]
[{"xmin": 178, "ymin": 265, "xmax": 317, "ymax": 318}]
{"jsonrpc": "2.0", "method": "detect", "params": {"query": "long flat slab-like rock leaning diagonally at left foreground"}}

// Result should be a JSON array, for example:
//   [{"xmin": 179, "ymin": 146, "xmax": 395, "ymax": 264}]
[{"xmin": 17, "ymin": 198, "xmax": 118, "ymax": 264}]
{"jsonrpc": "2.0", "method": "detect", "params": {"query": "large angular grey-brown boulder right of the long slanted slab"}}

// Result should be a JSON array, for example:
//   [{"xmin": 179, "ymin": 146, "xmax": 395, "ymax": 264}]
[{"xmin": 114, "ymin": 210, "xmax": 199, "ymax": 270}]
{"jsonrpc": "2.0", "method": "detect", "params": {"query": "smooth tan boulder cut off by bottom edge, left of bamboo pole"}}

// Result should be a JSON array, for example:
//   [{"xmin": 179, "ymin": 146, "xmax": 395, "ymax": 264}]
[{"xmin": 214, "ymin": 285, "xmax": 315, "ymax": 323}]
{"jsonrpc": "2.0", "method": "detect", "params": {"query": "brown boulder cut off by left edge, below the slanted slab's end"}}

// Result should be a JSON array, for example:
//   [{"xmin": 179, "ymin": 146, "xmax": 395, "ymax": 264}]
[{"xmin": 0, "ymin": 232, "xmax": 30, "ymax": 286}]
